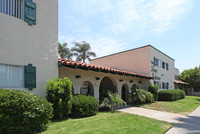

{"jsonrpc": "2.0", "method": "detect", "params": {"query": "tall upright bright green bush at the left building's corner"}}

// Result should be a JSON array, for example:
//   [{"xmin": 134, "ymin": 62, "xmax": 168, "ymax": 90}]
[{"xmin": 46, "ymin": 77, "xmax": 72, "ymax": 119}]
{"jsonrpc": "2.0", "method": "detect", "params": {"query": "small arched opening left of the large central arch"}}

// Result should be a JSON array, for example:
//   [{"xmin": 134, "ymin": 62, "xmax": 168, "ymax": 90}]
[{"xmin": 80, "ymin": 81, "xmax": 94, "ymax": 96}]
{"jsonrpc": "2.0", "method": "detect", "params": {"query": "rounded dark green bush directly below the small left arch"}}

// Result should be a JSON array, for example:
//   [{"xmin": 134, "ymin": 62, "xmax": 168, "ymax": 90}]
[{"xmin": 71, "ymin": 95, "xmax": 99, "ymax": 118}]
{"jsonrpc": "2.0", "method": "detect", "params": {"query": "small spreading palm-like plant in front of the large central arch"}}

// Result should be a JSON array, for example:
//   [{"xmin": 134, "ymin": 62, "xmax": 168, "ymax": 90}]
[{"xmin": 100, "ymin": 91, "xmax": 126, "ymax": 112}]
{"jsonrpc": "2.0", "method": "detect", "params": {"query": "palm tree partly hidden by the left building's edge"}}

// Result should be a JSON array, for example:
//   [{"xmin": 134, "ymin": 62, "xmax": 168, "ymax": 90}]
[{"xmin": 58, "ymin": 43, "xmax": 73, "ymax": 60}]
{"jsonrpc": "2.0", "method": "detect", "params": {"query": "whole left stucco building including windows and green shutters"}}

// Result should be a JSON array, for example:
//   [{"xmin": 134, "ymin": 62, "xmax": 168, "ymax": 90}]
[{"xmin": 0, "ymin": 0, "xmax": 58, "ymax": 96}]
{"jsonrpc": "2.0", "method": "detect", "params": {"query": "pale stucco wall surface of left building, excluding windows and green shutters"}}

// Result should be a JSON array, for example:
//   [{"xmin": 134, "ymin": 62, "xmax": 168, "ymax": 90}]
[{"xmin": 0, "ymin": 0, "xmax": 58, "ymax": 96}]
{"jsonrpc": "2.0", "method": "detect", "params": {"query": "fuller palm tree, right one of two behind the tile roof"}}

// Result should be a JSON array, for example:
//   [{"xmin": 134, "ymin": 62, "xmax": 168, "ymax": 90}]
[{"xmin": 71, "ymin": 41, "xmax": 96, "ymax": 63}]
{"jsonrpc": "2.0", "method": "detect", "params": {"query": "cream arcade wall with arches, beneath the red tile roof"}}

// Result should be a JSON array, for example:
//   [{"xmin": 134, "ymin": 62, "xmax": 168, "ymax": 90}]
[{"xmin": 59, "ymin": 66, "xmax": 150, "ymax": 99}]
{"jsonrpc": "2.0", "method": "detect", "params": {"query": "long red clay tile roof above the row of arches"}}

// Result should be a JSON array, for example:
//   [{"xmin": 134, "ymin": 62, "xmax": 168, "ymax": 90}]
[{"xmin": 58, "ymin": 58, "xmax": 153, "ymax": 79}]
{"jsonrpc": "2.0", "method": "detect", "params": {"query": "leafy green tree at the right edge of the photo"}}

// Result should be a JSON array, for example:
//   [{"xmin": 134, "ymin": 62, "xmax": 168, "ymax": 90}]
[{"xmin": 180, "ymin": 66, "xmax": 200, "ymax": 91}]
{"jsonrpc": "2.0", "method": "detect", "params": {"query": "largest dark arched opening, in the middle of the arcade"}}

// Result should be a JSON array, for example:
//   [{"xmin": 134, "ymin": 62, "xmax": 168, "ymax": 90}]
[{"xmin": 99, "ymin": 76, "xmax": 117, "ymax": 102}]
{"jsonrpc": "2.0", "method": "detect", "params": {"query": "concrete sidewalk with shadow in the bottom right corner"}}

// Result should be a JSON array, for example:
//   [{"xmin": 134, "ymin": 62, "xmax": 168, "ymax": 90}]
[{"xmin": 165, "ymin": 106, "xmax": 200, "ymax": 134}]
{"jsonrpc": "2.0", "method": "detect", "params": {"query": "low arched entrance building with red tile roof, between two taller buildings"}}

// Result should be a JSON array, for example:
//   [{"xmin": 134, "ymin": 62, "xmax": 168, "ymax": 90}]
[{"xmin": 58, "ymin": 59, "xmax": 153, "ymax": 100}]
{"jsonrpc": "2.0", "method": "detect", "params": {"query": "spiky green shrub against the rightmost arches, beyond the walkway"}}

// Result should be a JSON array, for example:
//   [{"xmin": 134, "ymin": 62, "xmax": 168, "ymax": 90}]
[{"xmin": 132, "ymin": 85, "xmax": 154, "ymax": 104}]
